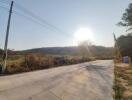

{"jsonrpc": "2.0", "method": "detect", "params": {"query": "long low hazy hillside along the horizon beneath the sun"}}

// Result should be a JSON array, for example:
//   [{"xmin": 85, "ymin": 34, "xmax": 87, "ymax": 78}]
[{"xmin": 0, "ymin": 45, "xmax": 114, "ymax": 58}]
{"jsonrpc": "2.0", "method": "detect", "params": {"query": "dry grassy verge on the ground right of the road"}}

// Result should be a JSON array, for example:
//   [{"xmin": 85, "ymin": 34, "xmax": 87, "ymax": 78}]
[{"xmin": 113, "ymin": 64, "xmax": 132, "ymax": 100}]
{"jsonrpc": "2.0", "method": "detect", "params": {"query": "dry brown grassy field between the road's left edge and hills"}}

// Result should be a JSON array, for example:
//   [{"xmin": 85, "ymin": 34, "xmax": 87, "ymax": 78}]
[{"xmin": 0, "ymin": 53, "xmax": 94, "ymax": 74}]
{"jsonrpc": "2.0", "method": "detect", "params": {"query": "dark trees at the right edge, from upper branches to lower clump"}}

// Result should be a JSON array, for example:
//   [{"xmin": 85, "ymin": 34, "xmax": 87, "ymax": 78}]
[{"xmin": 117, "ymin": 3, "xmax": 132, "ymax": 58}]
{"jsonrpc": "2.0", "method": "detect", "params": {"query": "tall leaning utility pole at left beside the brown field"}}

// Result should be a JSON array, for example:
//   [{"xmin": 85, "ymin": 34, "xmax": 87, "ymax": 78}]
[{"xmin": 2, "ymin": 1, "xmax": 14, "ymax": 73}]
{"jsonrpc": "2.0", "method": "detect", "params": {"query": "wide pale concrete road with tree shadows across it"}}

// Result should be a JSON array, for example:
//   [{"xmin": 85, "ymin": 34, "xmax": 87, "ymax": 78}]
[{"xmin": 0, "ymin": 60, "xmax": 113, "ymax": 100}]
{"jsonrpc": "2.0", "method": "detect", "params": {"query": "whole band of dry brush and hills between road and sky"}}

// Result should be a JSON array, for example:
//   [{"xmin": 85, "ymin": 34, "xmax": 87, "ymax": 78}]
[{"xmin": 0, "ymin": 42, "xmax": 113, "ymax": 74}]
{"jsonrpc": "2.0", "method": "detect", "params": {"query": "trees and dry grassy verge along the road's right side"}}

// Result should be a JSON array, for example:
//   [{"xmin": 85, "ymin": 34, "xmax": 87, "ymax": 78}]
[{"xmin": 113, "ymin": 3, "xmax": 132, "ymax": 100}]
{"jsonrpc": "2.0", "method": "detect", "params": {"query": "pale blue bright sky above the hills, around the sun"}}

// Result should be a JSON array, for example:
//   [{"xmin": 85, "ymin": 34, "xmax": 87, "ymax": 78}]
[{"xmin": 0, "ymin": 0, "xmax": 131, "ymax": 50}]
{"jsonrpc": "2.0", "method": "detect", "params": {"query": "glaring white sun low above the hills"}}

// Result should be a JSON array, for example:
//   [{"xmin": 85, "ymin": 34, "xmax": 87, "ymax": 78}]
[{"xmin": 74, "ymin": 28, "xmax": 93, "ymax": 42}]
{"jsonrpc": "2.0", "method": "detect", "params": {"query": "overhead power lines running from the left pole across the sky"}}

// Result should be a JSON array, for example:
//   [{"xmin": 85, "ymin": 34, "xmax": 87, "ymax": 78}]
[{"xmin": 0, "ymin": 1, "xmax": 70, "ymax": 36}]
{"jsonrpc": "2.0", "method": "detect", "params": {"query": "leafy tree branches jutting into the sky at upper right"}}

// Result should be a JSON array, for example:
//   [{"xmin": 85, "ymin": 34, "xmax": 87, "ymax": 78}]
[{"xmin": 118, "ymin": 3, "xmax": 132, "ymax": 30}]
